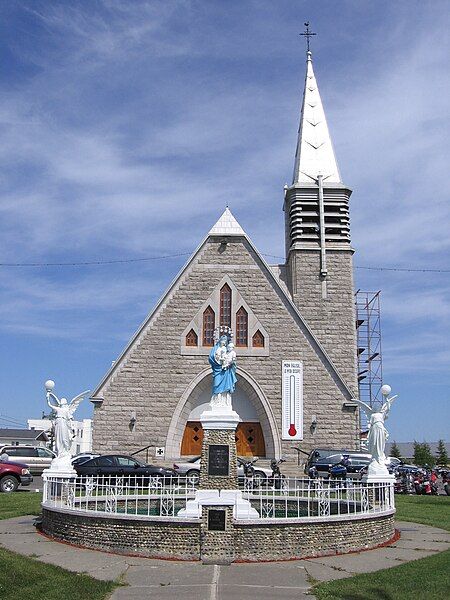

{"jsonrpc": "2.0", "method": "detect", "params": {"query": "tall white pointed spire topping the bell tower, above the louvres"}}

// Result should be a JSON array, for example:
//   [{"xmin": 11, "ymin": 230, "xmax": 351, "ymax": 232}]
[{"xmin": 292, "ymin": 52, "xmax": 342, "ymax": 184}]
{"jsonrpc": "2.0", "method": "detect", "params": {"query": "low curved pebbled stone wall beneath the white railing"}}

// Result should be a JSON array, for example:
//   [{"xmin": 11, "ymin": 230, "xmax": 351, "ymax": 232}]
[{"xmin": 42, "ymin": 507, "xmax": 395, "ymax": 561}]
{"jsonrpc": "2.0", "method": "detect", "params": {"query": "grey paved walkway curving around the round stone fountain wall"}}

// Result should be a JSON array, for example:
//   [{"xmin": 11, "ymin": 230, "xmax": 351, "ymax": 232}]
[{"xmin": 0, "ymin": 517, "xmax": 450, "ymax": 600}]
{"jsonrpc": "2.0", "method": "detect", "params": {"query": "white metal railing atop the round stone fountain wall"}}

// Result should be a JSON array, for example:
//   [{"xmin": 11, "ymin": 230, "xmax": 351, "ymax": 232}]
[{"xmin": 43, "ymin": 475, "xmax": 394, "ymax": 519}]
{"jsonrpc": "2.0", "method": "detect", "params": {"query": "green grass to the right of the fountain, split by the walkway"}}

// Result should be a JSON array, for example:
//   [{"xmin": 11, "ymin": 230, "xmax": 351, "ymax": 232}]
[{"xmin": 313, "ymin": 495, "xmax": 450, "ymax": 600}]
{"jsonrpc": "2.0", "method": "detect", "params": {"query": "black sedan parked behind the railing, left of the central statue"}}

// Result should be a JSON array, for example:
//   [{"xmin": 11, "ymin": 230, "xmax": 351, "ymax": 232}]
[{"xmin": 73, "ymin": 454, "xmax": 177, "ymax": 481}]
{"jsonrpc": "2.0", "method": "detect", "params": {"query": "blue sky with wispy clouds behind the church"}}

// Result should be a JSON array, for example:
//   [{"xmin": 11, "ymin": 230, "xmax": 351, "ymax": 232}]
[{"xmin": 0, "ymin": 0, "xmax": 450, "ymax": 441}]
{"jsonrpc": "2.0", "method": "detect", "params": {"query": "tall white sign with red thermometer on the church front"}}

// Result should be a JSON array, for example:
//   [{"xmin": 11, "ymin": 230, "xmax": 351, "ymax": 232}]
[{"xmin": 282, "ymin": 360, "xmax": 303, "ymax": 440}]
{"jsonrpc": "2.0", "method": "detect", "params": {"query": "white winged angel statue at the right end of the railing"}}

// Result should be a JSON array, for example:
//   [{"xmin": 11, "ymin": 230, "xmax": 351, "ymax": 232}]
[{"xmin": 355, "ymin": 385, "xmax": 397, "ymax": 474}]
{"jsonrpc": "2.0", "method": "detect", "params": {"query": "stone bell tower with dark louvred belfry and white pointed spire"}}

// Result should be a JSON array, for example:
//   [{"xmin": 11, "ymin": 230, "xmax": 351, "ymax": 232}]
[{"xmin": 284, "ymin": 44, "xmax": 358, "ymax": 397}]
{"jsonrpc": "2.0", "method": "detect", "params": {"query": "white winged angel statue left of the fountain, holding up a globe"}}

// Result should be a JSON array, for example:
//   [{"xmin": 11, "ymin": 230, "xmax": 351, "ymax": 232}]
[{"xmin": 45, "ymin": 380, "xmax": 90, "ymax": 460}]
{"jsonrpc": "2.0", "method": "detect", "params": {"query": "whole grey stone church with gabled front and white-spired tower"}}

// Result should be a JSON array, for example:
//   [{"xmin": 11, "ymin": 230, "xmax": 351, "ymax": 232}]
[{"xmin": 92, "ymin": 52, "xmax": 359, "ymax": 465}]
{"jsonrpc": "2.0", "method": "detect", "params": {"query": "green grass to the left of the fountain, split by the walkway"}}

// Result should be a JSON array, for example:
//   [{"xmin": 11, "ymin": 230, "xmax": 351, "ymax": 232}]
[{"xmin": 0, "ymin": 492, "xmax": 117, "ymax": 600}]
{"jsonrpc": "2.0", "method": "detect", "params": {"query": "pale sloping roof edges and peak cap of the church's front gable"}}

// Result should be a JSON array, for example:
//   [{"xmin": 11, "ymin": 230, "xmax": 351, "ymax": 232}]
[{"xmin": 91, "ymin": 208, "xmax": 353, "ymax": 403}]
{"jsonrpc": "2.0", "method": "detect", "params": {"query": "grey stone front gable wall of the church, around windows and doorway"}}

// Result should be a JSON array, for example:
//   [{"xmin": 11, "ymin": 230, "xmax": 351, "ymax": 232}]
[{"xmin": 93, "ymin": 238, "xmax": 358, "ymax": 465}]
